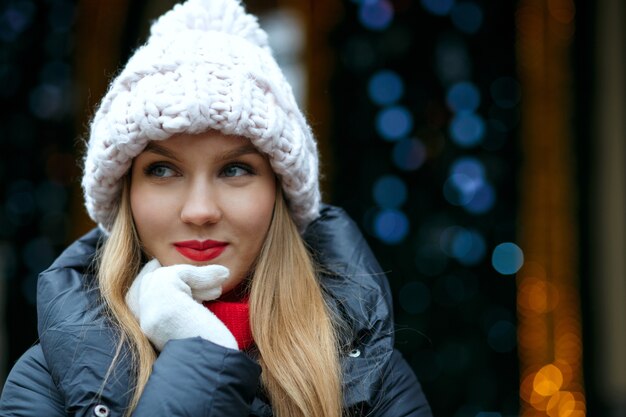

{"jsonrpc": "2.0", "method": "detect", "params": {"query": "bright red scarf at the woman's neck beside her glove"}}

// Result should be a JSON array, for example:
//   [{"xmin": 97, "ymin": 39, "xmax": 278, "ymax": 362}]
[{"xmin": 202, "ymin": 291, "xmax": 254, "ymax": 350}]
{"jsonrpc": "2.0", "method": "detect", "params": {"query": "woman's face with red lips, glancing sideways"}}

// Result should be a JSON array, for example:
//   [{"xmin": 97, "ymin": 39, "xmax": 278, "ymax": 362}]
[{"xmin": 130, "ymin": 131, "xmax": 276, "ymax": 293}]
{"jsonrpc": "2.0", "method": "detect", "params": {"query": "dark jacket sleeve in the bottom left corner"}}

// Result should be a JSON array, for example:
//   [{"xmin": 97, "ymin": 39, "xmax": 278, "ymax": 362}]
[{"xmin": 0, "ymin": 345, "xmax": 66, "ymax": 417}]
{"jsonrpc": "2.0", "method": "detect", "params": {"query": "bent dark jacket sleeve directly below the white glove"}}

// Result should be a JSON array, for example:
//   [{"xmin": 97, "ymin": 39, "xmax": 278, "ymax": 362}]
[{"xmin": 133, "ymin": 337, "xmax": 261, "ymax": 417}]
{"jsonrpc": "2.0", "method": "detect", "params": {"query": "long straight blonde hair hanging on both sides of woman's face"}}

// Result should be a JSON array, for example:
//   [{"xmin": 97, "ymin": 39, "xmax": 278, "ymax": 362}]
[{"xmin": 98, "ymin": 178, "xmax": 343, "ymax": 417}]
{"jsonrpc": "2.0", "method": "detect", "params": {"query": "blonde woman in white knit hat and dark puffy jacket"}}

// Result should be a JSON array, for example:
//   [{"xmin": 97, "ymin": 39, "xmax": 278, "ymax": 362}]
[{"xmin": 0, "ymin": 0, "xmax": 430, "ymax": 417}]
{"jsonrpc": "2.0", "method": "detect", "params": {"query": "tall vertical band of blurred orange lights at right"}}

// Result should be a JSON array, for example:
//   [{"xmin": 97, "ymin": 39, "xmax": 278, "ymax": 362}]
[{"xmin": 516, "ymin": 0, "xmax": 586, "ymax": 417}]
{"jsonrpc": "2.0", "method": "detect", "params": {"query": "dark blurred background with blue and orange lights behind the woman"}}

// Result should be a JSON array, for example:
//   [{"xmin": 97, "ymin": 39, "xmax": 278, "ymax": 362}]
[{"xmin": 0, "ymin": 0, "xmax": 626, "ymax": 417}]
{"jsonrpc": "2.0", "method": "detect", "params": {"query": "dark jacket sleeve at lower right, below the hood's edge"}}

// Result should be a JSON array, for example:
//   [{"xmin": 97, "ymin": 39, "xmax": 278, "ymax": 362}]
[{"xmin": 369, "ymin": 350, "xmax": 432, "ymax": 417}]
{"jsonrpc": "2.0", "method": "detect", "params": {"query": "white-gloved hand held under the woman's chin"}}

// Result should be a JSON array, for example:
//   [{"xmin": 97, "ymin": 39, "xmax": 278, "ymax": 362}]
[{"xmin": 126, "ymin": 259, "xmax": 238, "ymax": 351}]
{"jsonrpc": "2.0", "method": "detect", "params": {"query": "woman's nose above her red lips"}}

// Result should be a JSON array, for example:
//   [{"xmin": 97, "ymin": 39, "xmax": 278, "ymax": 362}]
[{"xmin": 180, "ymin": 180, "xmax": 222, "ymax": 226}]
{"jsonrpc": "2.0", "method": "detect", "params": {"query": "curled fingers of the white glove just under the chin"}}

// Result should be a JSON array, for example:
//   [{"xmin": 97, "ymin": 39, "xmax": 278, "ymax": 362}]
[{"xmin": 168, "ymin": 265, "xmax": 230, "ymax": 301}]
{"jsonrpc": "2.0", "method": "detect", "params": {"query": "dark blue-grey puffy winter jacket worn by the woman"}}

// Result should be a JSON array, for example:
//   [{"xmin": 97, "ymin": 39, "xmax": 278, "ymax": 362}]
[{"xmin": 0, "ymin": 206, "xmax": 431, "ymax": 417}]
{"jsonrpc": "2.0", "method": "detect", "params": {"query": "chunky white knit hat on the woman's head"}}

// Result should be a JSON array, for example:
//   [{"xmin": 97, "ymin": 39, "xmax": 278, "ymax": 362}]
[{"xmin": 82, "ymin": 0, "xmax": 320, "ymax": 231}]
